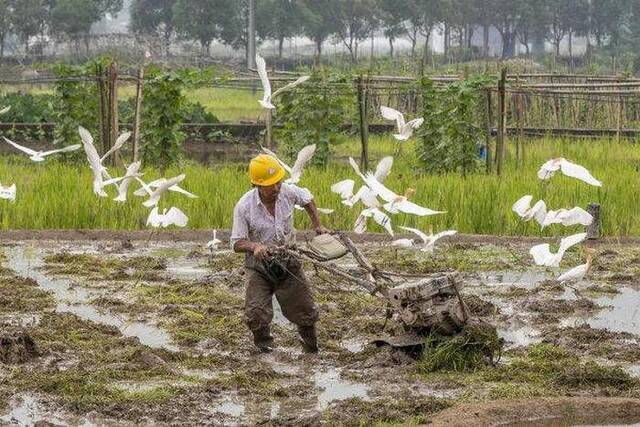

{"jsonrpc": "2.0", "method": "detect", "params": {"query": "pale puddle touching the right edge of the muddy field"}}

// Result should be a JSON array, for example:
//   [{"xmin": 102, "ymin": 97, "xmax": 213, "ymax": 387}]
[{"xmin": 561, "ymin": 288, "xmax": 640, "ymax": 335}]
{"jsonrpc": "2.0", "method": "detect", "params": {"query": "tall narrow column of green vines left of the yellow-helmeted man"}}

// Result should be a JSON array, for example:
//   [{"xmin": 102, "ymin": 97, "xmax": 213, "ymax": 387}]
[{"xmin": 140, "ymin": 69, "xmax": 186, "ymax": 169}]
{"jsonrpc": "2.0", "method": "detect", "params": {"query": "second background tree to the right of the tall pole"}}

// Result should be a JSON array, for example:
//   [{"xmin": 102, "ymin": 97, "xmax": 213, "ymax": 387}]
[{"xmin": 299, "ymin": 0, "xmax": 340, "ymax": 61}]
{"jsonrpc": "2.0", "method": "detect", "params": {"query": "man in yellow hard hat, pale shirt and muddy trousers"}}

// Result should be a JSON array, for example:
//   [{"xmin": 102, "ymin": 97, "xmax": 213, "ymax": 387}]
[{"xmin": 231, "ymin": 154, "xmax": 326, "ymax": 353}]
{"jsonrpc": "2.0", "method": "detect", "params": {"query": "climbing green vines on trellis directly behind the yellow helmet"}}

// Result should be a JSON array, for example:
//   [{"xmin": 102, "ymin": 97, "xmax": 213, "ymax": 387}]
[{"xmin": 274, "ymin": 71, "xmax": 355, "ymax": 165}]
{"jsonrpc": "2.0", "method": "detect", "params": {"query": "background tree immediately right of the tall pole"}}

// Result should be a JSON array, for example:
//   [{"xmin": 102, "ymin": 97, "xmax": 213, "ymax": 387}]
[{"xmin": 256, "ymin": 0, "xmax": 302, "ymax": 58}]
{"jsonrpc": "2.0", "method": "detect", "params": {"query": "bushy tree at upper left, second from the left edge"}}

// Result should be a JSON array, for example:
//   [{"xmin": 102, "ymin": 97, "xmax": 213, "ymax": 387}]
[{"xmin": 51, "ymin": 0, "xmax": 122, "ymax": 51}]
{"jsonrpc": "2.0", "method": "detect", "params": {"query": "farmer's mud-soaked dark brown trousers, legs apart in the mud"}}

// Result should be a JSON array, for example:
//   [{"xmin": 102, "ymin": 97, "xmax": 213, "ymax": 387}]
[{"xmin": 245, "ymin": 268, "xmax": 318, "ymax": 351}]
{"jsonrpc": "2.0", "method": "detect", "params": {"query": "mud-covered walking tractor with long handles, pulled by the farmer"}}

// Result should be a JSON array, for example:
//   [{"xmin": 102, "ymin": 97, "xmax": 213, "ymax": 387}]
[{"xmin": 283, "ymin": 234, "xmax": 469, "ymax": 348}]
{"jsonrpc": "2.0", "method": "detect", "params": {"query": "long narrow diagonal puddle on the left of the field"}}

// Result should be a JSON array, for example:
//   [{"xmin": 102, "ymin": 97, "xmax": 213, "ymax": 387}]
[{"xmin": 5, "ymin": 247, "xmax": 178, "ymax": 351}]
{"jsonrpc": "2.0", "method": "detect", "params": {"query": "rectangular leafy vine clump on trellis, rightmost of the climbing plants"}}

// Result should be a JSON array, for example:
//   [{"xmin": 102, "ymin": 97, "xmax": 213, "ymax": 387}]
[{"xmin": 417, "ymin": 76, "xmax": 488, "ymax": 175}]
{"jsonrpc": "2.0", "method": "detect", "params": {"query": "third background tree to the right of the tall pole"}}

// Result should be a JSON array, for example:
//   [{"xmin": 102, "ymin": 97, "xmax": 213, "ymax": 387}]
[{"xmin": 334, "ymin": 0, "xmax": 375, "ymax": 62}]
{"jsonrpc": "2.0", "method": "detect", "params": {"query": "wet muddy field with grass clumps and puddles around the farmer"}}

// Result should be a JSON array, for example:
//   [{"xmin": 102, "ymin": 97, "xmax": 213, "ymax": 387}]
[{"xmin": 0, "ymin": 239, "xmax": 640, "ymax": 425}]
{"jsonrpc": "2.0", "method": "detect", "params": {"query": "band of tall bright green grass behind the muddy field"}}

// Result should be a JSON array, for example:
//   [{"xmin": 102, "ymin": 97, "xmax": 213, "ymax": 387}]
[{"xmin": 0, "ymin": 137, "xmax": 640, "ymax": 236}]
